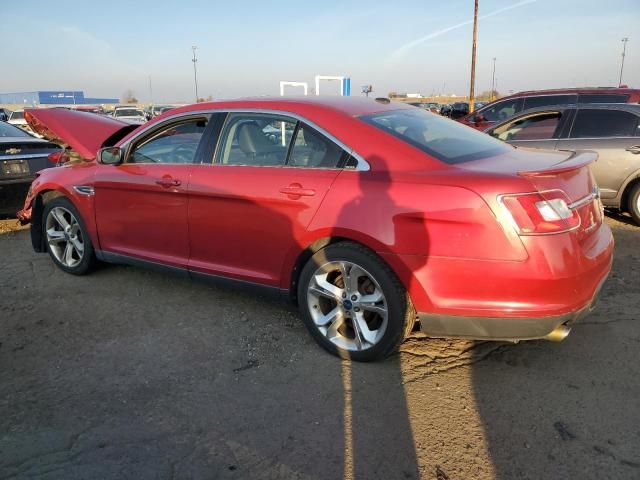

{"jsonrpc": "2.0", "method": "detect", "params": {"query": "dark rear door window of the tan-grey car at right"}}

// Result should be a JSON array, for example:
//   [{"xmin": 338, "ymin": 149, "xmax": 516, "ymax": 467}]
[{"xmin": 571, "ymin": 109, "xmax": 638, "ymax": 138}]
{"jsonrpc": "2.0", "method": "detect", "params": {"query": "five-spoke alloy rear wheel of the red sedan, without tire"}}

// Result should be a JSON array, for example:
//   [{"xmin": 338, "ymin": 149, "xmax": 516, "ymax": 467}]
[{"xmin": 307, "ymin": 261, "xmax": 389, "ymax": 351}]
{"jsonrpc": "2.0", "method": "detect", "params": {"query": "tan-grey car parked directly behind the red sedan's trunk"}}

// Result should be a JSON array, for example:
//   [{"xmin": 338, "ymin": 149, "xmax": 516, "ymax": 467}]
[{"xmin": 486, "ymin": 103, "xmax": 640, "ymax": 225}]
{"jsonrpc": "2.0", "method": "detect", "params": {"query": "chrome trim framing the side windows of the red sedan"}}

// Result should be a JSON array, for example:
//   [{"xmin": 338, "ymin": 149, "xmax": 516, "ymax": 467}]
[{"xmin": 120, "ymin": 108, "xmax": 371, "ymax": 172}]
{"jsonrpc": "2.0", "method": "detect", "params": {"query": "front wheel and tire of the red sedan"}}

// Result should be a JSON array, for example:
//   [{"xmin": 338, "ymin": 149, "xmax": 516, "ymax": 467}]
[{"xmin": 42, "ymin": 197, "xmax": 96, "ymax": 275}]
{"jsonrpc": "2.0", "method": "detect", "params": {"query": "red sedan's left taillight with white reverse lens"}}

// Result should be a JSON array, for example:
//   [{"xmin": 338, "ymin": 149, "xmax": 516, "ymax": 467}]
[{"xmin": 500, "ymin": 190, "xmax": 580, "ymax": 235}]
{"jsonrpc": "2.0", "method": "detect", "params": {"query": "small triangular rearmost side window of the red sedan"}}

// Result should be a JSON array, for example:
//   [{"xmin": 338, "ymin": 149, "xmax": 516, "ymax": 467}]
[{"xmin": 288, "ymin": 123, "xmax": 346, "ymax": 168}]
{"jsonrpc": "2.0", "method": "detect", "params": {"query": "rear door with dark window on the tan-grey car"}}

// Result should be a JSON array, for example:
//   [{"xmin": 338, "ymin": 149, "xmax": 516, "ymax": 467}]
[{"xmin": 556, "ymin": 108, "xmax": 640, "ymax": 203}]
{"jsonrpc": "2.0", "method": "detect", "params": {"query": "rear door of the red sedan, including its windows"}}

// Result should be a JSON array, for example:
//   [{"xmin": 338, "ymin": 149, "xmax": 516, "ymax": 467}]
[{"xmin": 189, "ymin": 112, "xmax": 348, "ymax": 287}]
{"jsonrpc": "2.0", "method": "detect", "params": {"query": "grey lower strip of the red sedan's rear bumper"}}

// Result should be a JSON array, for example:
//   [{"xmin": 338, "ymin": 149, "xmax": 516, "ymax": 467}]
[{"xmin": 418, "ymin": 278, "xmax": 606, "ymax": 341}]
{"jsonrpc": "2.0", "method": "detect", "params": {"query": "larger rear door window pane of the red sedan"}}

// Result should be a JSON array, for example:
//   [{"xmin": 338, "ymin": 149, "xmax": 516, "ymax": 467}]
[{"xmin": 215, "ymin": 113, "xmax": 297, "ymax": 166}]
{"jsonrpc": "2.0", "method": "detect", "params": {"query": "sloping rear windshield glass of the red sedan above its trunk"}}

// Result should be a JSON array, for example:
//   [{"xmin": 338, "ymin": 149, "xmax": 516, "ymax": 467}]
[{"xmin": 360, "ymin": 109, "xmax": 512, "ymax": 164}]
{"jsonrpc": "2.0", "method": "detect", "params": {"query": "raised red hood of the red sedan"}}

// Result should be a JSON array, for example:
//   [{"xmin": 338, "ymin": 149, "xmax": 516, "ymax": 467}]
[{"xmin": 24, "ymin": 108, "xmax": 139, "ymax": 161}]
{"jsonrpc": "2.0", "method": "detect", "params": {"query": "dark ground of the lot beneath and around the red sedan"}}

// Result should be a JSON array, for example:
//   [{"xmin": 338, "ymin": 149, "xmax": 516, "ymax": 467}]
[{"xmin": 0, "ymin": 219, "xmax": 640, "ymax": 480}]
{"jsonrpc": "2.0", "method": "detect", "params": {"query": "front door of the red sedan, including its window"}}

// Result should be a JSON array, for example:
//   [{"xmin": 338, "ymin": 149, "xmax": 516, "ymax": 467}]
[{"xmin": 94, "ymin": 114, "xmax": 208, "ymax": 267}]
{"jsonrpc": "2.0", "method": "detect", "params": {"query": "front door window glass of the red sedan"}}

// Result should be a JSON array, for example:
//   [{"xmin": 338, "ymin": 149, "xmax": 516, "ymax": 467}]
[{"xmin": 128, "ymin": 118, "xmax": 207, "ymax": 163}]
